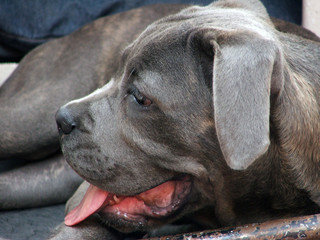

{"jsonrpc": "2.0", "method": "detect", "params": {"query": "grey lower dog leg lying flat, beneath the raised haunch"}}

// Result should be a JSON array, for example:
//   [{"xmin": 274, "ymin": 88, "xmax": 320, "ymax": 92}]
[{"xmin": 0, "ymin": 154, "xmax": 82, "ymax": 210}]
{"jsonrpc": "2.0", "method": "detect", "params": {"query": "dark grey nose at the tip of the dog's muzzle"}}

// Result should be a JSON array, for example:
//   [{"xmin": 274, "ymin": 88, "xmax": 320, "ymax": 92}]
[{"xmin": 56, "ymin": 107, "xmax": 76, "ymax": 135}]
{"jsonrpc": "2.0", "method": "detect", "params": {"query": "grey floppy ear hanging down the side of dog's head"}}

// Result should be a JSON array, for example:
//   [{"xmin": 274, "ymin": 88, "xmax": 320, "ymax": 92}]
[{"xmin": 211, "ymin": 33, "xmax": 283, "ymax": 170}]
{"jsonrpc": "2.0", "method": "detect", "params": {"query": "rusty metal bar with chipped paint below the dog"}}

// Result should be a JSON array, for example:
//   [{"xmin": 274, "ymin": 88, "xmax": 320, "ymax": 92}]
[{"xmin": 149, "ymin": 214, "xmax": 320, "ymax": 240}]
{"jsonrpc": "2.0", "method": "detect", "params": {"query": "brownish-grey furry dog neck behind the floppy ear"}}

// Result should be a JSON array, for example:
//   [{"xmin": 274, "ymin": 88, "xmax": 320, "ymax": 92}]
[{"xmin": 271, "ymin": 33, "xmax": 320, "ymax": 203}]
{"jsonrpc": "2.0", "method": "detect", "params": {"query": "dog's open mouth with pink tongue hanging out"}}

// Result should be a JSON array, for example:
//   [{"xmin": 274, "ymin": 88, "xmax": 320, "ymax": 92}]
[{"xmin": 65, "ymin": 176, "xmax": 191, "ymax": 226}]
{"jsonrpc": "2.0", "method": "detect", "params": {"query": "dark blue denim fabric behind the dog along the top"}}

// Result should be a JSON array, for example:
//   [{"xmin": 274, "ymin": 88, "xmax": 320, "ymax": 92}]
[{"xmin": 0, "ymin": 0, "xmax": 302, "ymax": 62}]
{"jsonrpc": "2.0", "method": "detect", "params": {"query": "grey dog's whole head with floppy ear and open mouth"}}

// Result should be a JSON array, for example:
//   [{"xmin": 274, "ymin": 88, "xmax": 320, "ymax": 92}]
[{"xmin": 56, "ymin": 0, "xmax": 283, "ymax": 231}]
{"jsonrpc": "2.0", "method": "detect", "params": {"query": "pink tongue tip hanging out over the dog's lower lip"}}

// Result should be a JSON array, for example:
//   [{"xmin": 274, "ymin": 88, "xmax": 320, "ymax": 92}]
[{"xmin": 64, "ymin": 184, "xmax": 109, "ymax": 226}]
